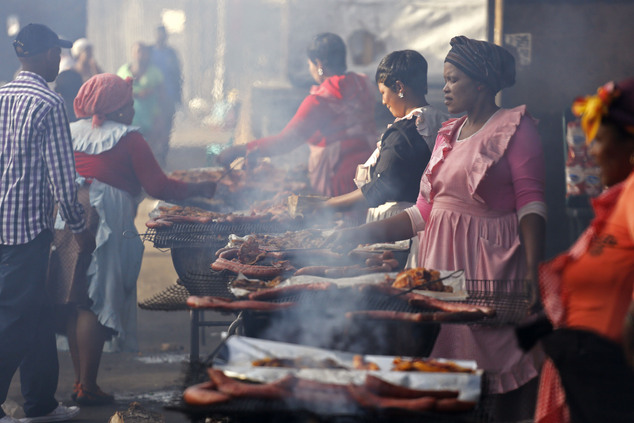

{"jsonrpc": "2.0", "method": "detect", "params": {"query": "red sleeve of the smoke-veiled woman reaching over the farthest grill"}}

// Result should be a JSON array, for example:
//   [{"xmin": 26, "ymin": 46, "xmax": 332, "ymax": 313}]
[{"xmin": 247, "ymin": 95, "xmax": 334, "ymax": 151}]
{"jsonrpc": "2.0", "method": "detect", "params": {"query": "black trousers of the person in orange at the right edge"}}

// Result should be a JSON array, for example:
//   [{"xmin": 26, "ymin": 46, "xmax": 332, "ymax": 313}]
[{"xmin": 542, "ymin": 329, "xmax": 634, "ymax": 423}]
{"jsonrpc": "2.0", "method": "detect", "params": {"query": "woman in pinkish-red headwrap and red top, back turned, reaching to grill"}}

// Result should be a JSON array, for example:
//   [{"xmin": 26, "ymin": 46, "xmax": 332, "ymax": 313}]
[{"xmin": 49, "ymin": 73, "xmax": 216, "ymax": 405}]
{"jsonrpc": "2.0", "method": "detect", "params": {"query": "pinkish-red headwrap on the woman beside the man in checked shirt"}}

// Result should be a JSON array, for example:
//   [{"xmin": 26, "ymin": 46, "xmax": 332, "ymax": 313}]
[{"xmin": 73, "ymin": 73, "xmax": 132, "ymax": 128}]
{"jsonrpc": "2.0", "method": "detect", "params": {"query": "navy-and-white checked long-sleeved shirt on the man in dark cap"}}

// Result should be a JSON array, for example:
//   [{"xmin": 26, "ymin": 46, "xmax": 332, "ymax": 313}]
[{"xmin": 0, "ymin": 71, "xmax": 85, "ymax": 245}]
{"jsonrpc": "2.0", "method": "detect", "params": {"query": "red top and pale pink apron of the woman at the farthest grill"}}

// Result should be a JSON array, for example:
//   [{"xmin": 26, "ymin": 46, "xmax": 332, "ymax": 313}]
[{"xmin": 247, "ymin": 72, "xmax": 377, "ymax": 196}]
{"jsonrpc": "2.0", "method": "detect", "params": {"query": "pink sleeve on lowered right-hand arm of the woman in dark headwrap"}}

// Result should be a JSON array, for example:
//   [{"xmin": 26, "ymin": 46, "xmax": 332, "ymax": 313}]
[{"xmin": 506, "ymin": 116, "xmax": 545, "ymax": 210}]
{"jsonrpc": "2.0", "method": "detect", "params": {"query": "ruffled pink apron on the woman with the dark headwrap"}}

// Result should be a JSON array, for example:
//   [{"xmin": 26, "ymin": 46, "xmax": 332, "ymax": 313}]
[{"xmin": 419, "ymin": 128, "xmax": 542, "ymax": 393}]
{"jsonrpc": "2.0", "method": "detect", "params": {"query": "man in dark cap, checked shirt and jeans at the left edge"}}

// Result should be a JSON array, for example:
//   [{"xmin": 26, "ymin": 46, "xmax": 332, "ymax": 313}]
[{"xmin": 0, "ymin": 24, "xmax": 95, "ymax": 423}]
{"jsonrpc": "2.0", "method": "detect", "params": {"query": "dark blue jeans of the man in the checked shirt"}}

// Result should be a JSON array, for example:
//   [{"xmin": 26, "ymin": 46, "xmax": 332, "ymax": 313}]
[{"xmin": 0, "ymin": 230, "xmax": 59, "ymax": 418}]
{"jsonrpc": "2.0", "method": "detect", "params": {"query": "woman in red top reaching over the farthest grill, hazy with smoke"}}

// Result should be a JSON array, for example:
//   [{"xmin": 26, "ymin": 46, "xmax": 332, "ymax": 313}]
[{"xmin": 218, "ymin": 33, "xmax": 377, "ymax": 197}]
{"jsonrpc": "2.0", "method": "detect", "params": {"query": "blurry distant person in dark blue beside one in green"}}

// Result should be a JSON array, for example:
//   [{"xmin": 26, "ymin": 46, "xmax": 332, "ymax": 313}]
[{"xmin": 150, "ymin": 25, "xmax": 183, "ymax": 154}]
